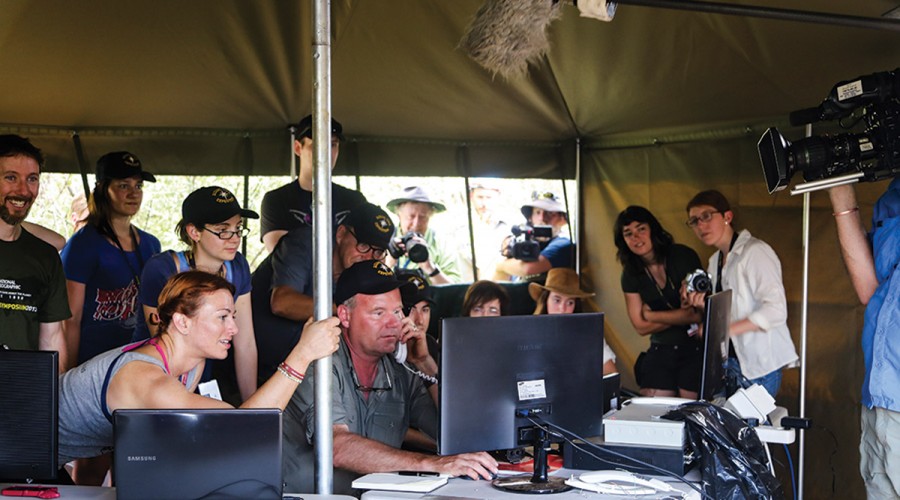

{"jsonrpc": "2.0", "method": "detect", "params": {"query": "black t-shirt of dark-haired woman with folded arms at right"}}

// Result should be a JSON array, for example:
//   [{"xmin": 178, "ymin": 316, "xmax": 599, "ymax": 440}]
[{"xmin": 622, "ymin": 243, "xmax": 703, "ymax": 345}]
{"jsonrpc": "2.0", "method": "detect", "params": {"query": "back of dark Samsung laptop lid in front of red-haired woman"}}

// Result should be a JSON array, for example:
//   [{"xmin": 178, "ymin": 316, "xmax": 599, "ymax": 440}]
[{"xmin": 113, "ymin": 409, "xmax": 283, "ymax": 500}]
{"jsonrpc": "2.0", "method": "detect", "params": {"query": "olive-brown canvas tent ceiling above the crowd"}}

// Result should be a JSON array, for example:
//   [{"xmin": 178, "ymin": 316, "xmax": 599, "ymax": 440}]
[{"xmin": 0, "ymin": 0, "xmax": 900, "ymax": 177}]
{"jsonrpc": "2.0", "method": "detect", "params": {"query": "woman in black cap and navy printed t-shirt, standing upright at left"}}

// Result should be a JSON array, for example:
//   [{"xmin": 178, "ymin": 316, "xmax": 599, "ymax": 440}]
[{"xmin": 60, "ymin": 151, "xmax": 160, "ymax": 485}]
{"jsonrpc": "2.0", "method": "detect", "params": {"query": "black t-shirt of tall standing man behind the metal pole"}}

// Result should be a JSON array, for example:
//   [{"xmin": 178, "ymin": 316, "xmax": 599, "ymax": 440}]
[{"xmin": 259, "ymin": 180, "xmax": 366, "ymax": 239}]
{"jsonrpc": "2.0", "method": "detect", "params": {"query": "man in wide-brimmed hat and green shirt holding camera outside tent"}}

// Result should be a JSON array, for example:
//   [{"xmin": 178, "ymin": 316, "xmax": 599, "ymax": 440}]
[{"xmin": 386, "ymin": 186, "xmax": 462, "ymax": 284}]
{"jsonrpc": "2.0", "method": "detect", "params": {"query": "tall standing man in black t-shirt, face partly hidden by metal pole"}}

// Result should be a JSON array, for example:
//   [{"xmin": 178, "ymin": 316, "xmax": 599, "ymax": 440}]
[{"xmin": 260, "ymin": 115, "xmax": 366, "ymax": 252}]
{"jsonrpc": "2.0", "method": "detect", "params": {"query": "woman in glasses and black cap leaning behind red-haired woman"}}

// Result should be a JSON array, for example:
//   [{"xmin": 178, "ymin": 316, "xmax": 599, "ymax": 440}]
[{"xmin": 134, "ymin": 186, "xmax": 259, "ymax": 404}]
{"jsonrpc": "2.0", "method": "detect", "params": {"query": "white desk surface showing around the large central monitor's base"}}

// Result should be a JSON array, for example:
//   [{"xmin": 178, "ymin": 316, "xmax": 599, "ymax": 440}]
[{"xmin": 362, "ymin": 469, "xmax": 699, "ymax": 500}]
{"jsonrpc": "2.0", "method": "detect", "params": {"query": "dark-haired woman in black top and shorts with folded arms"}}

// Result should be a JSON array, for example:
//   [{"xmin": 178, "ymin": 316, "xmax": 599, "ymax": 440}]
[{"xmin": 613, "ymin": 206, "xmax": 703, "ymax": 399}]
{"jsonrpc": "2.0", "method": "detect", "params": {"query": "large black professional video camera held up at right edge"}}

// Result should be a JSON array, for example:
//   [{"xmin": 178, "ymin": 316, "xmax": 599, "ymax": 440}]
[{"xmin": 758, "ymin": 68, "xmax": 900, "ymax": 194}]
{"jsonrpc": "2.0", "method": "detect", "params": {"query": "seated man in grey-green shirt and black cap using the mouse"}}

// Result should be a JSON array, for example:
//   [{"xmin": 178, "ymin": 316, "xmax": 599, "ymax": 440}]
[{"xmin": 284, "ymin": 260, "xmax": 497, "ymax": 493}]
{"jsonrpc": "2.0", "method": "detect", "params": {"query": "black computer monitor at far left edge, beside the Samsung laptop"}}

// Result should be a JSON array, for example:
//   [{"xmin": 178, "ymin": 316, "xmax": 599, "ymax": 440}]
[{"xmin": 0, "ymin": 347, "xmax": 59, "ymax": 482}]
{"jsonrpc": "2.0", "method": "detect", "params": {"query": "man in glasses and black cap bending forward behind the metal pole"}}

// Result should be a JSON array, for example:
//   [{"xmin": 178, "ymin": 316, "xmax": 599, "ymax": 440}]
[{"xmin": 250, "ymin": 202, "xmax": 394, "ymax": 380}]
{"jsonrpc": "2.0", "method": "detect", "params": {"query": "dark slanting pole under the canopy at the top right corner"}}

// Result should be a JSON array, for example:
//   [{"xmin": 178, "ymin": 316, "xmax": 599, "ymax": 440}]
[{"xmin": 616, "ymin": 0, "xmax": 900, "ymax": 31}]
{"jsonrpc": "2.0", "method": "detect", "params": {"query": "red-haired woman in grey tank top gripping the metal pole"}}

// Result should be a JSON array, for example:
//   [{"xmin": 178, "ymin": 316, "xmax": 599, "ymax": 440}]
[{"xmin": 58, "ymin": 272, "xmax": 340, "ymax": 474}]
